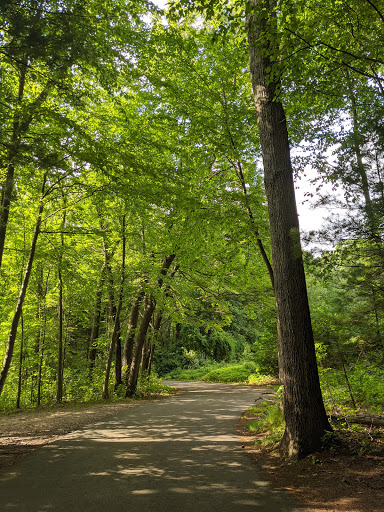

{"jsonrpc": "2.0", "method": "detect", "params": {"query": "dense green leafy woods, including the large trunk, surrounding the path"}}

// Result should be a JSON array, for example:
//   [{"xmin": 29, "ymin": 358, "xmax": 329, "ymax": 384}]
[{"xmin": 0, "ymin": 0, "xmax": 384, "ymax": 456}]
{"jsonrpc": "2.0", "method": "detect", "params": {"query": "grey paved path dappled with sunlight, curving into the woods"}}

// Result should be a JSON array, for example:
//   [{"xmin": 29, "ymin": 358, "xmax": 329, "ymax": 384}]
[{"xmin": 0, "ymin": 383, "xmax": 303, "ymax": 512}]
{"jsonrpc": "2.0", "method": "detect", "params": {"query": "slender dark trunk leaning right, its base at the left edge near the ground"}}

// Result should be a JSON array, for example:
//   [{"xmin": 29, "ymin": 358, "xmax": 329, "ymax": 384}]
[{"xmin": 0, "ymin": 175, "xmax": 46, "ymax": 395}]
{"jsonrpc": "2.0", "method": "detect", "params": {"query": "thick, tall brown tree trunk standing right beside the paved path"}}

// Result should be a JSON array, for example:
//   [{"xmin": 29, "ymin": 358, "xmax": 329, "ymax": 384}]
[{"xmin": 247, "ymin": 0, "xmax": 331, "ymax": 457}]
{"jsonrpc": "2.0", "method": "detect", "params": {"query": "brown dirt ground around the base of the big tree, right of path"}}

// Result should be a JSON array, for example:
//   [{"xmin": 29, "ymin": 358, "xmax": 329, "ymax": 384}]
[{"xmin": 239, "ymin": 415, "xmax": 384, "ymax": 512}]
